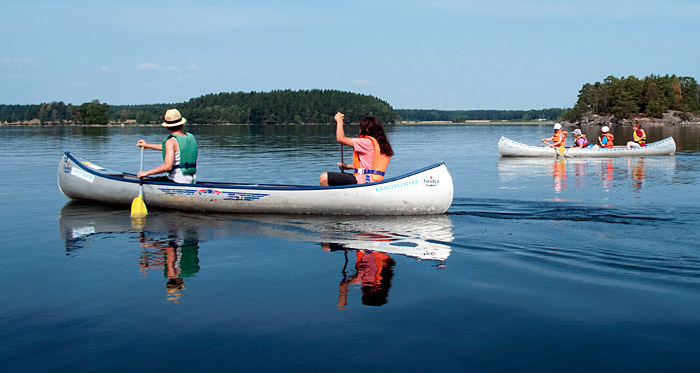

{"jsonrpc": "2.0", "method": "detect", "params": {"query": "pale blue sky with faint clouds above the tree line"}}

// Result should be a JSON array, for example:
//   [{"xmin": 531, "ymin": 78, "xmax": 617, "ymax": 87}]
[{"xmin": 0, "ymin": 0, "xmax": 700, "ymax": 109}]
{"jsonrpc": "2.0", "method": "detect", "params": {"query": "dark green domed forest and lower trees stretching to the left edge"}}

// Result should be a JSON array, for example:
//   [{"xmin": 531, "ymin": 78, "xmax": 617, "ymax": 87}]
[{"xmin": 0, "ymin": 90, "xmax": 399, "ymax": 124}]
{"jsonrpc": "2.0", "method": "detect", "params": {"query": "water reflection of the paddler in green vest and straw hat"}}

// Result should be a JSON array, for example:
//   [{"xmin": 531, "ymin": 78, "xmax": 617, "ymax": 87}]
[{"xmin": 139, "ymin": 230, "xmax": 199, "ymax": 303}]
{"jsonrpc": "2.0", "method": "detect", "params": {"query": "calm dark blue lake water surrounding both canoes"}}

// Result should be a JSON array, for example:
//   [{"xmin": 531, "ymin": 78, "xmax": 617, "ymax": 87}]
[{"xmin": 0, "ymin": 125, "xmax": 700, "ymax": 371}]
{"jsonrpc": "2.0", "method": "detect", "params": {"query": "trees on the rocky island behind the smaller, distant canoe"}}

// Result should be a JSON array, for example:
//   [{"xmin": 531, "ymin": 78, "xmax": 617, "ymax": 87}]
[{"xmin": 563, "ymin": 75, "xmax": 700, "ymax": 120}]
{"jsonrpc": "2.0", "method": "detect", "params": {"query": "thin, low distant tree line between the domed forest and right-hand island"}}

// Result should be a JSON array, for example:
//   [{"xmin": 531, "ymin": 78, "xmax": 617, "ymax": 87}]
[{"xmin": 396, "ymin": 108, "xmax": 565, "ymax": 123}]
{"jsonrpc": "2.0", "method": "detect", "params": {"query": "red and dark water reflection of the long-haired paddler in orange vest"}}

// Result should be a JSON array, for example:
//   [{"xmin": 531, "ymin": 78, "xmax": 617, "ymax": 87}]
[{"xmin": 321, "ymin": 243, "xmax": 396, "ymax": 310}]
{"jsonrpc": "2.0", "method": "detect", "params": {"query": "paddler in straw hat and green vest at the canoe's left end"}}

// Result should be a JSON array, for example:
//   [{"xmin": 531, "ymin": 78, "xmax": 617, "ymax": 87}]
[{"xmin": 136, "ymin": 109, "xmax": 197, "ymax": 184}]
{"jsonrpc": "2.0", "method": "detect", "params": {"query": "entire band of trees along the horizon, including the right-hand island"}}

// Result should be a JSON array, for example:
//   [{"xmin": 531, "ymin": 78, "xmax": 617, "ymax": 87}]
[{"xmin": 0, "ymin": 75, "xmax": 700, "ymax": 125}]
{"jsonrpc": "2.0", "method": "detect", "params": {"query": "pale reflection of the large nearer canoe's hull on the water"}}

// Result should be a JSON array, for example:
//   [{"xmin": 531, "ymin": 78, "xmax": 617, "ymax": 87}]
[{"xmin": 59, "ymin": 201, "xmax": 454, "ymax": 261}]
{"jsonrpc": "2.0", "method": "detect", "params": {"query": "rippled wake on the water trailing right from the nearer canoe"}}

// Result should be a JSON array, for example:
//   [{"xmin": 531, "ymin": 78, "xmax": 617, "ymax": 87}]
[{"xmin": 450, "ymin": 199, "xmax": 700, "ymax": 283}]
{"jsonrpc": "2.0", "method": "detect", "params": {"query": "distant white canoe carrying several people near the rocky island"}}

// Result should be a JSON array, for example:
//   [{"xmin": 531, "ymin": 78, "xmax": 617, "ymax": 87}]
[{"xmin": 498, "ymin": 137, "xmax": 676, "ymax": 158}]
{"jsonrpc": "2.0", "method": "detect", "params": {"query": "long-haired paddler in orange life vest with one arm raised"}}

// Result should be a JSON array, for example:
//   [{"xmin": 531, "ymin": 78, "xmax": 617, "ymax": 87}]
[{"xmin": 319, "ymin": 112, "xmax": 394, "ymax": 186}]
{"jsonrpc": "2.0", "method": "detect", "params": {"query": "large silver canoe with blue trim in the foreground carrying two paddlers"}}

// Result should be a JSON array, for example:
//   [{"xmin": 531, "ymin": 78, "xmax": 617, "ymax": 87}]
[{"xmin": 58, "ymin": 152, "xmax": 453, "ymax": 215}]
